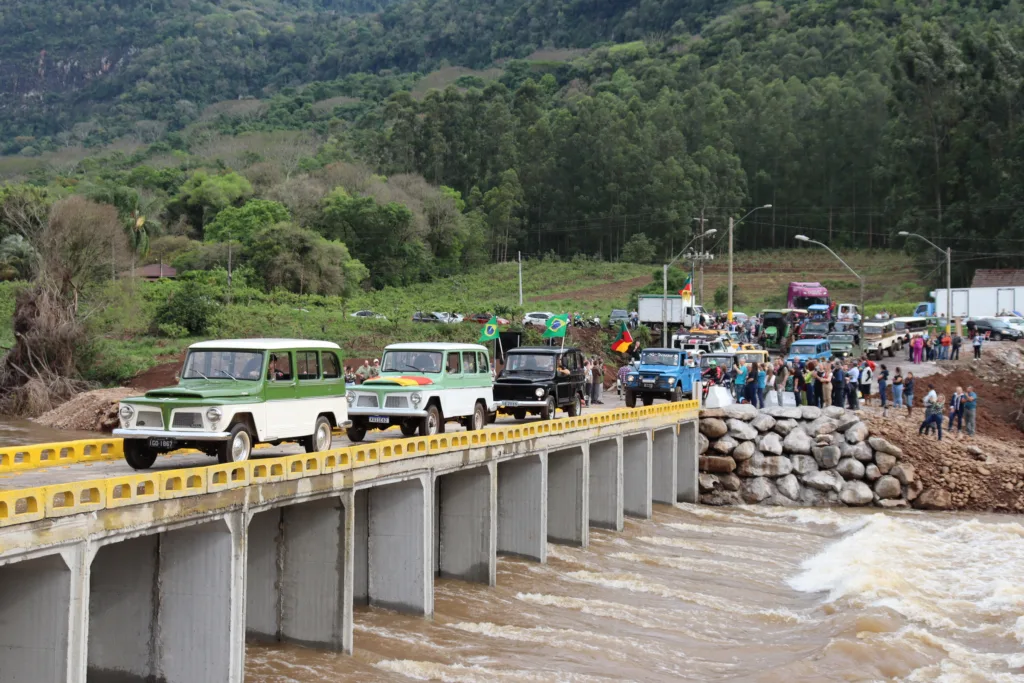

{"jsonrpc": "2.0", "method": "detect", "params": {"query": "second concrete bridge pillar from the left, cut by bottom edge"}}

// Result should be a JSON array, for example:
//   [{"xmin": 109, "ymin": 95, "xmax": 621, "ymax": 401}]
[{"xmin": 88, "ymin": 515, "xmax": 245, "ymax": 683}]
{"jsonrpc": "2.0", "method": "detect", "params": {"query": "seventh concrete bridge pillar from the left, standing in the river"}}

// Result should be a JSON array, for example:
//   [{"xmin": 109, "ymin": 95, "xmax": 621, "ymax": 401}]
[{"xmin": 548, "ymin": 446, "xmax": 590, "ymax": 548}]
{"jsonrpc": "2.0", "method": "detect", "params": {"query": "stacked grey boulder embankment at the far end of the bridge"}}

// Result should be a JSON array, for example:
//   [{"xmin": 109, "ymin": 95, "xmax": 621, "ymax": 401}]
[{"xmin": 697, "ymin": 405, "xmax": 933, "ymax": 508}]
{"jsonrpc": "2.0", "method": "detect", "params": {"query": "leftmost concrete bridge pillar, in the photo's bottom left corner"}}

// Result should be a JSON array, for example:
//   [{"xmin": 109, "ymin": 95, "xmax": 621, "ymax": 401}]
[{"xmin": 0, "ymin": 555, "xmax": 74, "ymax": 683}]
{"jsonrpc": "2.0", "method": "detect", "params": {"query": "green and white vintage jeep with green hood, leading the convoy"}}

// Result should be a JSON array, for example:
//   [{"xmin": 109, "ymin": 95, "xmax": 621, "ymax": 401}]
[{"xmin": 114, "ymin": 339, "xmax": 349, "ymax": 469}]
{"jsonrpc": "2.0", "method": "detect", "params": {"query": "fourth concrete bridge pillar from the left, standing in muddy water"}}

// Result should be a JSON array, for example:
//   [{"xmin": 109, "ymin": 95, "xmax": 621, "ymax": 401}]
[{"xmin": 352, "ymin": 474, "xmax": 434, "ymax": 616}]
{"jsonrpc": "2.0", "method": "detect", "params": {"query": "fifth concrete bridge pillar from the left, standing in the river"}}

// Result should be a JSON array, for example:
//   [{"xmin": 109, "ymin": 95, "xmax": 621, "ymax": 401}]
[{"xmin": 434, "ymin": 463, "xmax": 498, "ymax": 586}]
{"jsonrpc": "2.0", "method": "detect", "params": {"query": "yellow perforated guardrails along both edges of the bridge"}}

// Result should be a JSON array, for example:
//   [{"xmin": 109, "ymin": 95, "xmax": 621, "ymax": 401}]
[{"xmin": 0, "ymin": 400, "xmax": 699, "ymax": 527}]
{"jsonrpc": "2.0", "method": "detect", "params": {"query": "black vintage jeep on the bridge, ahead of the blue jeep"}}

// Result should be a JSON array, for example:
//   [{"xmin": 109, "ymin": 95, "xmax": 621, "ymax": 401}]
[{"xmin": 495, "ymin": 346, "xmax": 584, "ymax": 420}]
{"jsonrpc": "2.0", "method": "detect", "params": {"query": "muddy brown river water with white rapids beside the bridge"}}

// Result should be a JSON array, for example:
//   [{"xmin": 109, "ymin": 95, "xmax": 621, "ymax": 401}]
[{"xmin": 246, "ymin": 505, "xmax": 1024, "ymax": 683}]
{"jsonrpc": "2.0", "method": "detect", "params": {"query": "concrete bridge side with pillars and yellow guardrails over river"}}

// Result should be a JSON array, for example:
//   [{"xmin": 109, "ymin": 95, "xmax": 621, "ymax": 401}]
[{"xmin": 0, "ymin": 401, "xmax": 698, "ymax": 683}]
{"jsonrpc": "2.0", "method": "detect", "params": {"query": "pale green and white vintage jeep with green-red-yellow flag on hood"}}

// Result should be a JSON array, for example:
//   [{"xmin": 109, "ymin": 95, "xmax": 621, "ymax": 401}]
[{"xmin": 347, "ymin": 344, "xmax": 497, "ymax": 442}]
